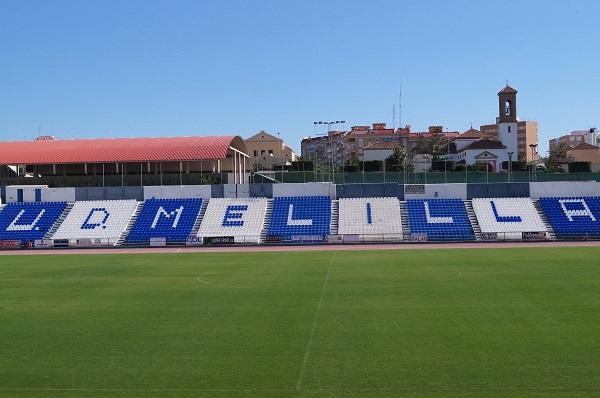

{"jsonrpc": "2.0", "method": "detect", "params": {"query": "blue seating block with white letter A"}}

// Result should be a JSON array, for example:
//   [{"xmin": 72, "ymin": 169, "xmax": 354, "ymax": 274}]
[{"xmin": 539, "ymin": 197, "xmax": 600, "ymax": 238}]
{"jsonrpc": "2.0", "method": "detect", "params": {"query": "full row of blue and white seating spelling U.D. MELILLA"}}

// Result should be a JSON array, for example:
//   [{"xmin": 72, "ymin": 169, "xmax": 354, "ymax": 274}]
[{"xmin": 0, "ymin": 190, "xmax": 600, "ymax": 247}]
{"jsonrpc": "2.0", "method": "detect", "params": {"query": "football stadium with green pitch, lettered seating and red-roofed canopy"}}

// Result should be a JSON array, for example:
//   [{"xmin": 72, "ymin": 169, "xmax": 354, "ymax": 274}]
[{"xmin": 0, "ymin": 137, "xmax": 600, "ymax": 397}]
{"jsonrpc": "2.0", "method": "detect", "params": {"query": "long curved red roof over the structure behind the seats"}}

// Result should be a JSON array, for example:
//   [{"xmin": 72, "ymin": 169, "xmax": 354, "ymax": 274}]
[{"xmin": 0, "ymin": 136, "xmax": 246, "ymax": 165}]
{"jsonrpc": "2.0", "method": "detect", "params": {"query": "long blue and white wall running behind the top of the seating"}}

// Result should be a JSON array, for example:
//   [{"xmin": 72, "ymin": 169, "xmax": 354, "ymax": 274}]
[{"xmin": 5, "ymin": 181, "xmax": 600, "ymax": 204}]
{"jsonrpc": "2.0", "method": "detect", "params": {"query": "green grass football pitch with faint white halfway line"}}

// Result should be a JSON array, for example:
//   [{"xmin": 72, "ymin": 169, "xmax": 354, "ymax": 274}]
[{"xmin": 0, "ymin": 247, "xmax": 600, "ymax": 398}]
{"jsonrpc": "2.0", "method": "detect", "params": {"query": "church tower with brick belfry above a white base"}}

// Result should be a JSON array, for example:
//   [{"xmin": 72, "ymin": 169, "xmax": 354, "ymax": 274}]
[{"xmin": 497, "ymin": 84, "xmax": 519, "ymax": 155}]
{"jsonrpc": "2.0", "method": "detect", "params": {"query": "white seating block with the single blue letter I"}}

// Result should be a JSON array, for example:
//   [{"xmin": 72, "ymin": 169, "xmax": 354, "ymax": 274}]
[{"xmin": 338, "ymin": 198, "xmax": 403, "ymax": 241}]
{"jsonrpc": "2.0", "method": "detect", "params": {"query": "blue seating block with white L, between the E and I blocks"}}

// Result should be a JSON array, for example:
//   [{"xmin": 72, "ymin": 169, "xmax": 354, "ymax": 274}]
[{"xmin": 269, "ymin": 196, "xmax": 331, "ymax": 241}]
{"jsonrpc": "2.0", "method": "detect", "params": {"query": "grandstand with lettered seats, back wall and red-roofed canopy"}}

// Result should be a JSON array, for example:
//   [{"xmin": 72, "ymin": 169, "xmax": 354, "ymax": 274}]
[{"xmin": 0, "ymin": 136, "xmax": 600, "ymax": 247}]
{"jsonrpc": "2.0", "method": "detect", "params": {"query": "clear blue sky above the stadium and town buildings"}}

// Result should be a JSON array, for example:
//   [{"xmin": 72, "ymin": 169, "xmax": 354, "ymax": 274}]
[{"xmin": 0, "ymin": 0, "xmax": 600, "ymax": 151}]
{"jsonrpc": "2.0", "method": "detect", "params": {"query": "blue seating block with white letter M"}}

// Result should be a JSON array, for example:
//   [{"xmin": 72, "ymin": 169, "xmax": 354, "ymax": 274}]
[{"xmin": 126, "ymin": 198, "xmax": 202, "ymax": 243}]
